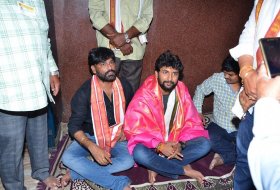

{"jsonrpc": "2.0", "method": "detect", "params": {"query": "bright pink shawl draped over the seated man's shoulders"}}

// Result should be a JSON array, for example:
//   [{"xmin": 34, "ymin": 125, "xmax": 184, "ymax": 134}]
[{"xmin": 124, "ymin": 75, "xmax": 209, "ymax": 154}]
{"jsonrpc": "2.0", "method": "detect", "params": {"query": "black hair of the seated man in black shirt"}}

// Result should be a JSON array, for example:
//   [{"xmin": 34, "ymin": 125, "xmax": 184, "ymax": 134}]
[{"xmin": 88, "ymin": 47, "xmax": 116, "ymax": 67}]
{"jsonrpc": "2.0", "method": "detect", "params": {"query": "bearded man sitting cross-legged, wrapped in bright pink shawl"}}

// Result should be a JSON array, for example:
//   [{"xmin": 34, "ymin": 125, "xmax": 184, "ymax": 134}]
[{"xmin": 124, "ymin": 51, "xmax": 210, "ymax": 183}]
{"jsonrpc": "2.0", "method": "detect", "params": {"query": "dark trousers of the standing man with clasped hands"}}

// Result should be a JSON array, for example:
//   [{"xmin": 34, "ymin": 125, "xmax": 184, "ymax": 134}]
[{"xmin": 116, "ymin": 58, "xmax": 143, "ymax": 92}]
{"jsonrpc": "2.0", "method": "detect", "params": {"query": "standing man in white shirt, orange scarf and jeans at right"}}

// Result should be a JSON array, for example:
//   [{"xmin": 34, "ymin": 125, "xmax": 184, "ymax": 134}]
[{"xmin": 230, "ymin": 0, "xmax": 280, "ymax": 190}]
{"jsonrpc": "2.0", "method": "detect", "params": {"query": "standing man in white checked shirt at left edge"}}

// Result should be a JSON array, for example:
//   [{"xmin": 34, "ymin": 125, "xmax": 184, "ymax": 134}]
[{"xmin": 0, "ymin": 0, "xmax": 60, "ymax": 190}]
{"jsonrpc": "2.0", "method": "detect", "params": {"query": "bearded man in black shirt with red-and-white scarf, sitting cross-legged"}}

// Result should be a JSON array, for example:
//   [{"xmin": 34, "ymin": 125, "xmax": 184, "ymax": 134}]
[{"xmin": 62, "ymin": 47, "xmax": 134, "ymax": 190}]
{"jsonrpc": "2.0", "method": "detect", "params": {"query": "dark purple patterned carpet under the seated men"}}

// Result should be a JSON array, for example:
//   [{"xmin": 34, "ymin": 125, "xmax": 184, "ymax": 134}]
[{"xmin": 37, "ymin": 114, "xmax": 234, "ymax": 190}]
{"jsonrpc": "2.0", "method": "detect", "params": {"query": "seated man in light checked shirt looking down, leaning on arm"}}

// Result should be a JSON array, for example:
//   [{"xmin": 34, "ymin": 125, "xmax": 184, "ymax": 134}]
[{"xmin": 193, "ymin": 56, "xmax": 241, "ymax": 170}]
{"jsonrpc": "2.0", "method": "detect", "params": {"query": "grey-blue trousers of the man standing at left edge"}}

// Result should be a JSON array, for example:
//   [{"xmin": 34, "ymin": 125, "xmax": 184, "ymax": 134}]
[{"xmin": 0, "ymin": 109, "xmax": 49, "ymax": 190}]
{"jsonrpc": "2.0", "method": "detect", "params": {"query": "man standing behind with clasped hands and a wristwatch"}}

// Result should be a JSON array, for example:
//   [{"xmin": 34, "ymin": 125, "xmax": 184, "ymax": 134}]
[{"xmin": 89, "ymin": 0, "xmax": 153, "ymax": 92}]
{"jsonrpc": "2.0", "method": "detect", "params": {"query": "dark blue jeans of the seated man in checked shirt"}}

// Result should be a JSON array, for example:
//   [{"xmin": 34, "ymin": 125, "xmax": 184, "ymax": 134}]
[{"xmin": 207, "ymin": 122, "xmax": 237, "ymax": 164}]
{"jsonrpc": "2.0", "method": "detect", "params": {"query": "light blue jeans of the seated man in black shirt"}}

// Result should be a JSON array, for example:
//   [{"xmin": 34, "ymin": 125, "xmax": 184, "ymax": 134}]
[{"xmin": 62, "ymin": 135, "xmax": 134, "ymax": 190}]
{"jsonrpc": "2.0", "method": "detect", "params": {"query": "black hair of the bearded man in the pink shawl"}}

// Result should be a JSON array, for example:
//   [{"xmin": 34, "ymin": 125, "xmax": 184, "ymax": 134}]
[{"xmin": 155, "ymin": 50, "xmax": 184, "ymax": 80}]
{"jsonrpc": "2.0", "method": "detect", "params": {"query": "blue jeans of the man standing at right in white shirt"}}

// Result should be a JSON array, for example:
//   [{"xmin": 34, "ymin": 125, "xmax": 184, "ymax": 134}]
[{"xmin": 233, "ymin": 112, "xmax": 255, "ymax": 190}]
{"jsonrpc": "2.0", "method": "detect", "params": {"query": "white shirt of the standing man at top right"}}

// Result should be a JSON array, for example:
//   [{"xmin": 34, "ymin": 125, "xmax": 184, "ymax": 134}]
[{"xmin": 230, "ymin": 0, "xmax": 280, "ymax": 68}]
